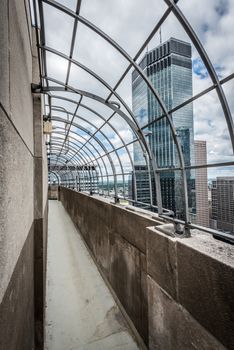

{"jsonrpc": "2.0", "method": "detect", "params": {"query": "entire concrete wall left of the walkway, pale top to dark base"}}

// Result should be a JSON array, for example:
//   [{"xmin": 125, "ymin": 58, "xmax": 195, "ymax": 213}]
[{"xmin": 0, "ymin": 0, "xmax": 47, "ymax": 350}]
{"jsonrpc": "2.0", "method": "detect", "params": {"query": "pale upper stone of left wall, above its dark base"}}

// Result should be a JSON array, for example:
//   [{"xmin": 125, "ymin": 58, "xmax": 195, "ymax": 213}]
[{"xmin": 0, "ymin": 0, "xmax": 33, "ymax": 302}]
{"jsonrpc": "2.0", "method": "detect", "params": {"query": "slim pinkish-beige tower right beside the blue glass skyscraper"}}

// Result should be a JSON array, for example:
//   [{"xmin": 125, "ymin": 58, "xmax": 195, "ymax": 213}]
[{"xmin": 194, "ymin": 140, "xmax": 209, "ymax": 227}]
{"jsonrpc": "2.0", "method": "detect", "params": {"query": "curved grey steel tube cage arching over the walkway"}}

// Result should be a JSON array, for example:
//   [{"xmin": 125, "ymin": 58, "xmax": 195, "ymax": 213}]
[{"xmin": 29, "ymin": 0, "xmax": 234, "ymax": 238}]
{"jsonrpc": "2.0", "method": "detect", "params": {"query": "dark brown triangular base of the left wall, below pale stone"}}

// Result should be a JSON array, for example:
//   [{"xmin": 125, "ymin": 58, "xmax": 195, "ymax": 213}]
[{"xmin": 0, "ymin": 225, "xmax": 34, "ymax": 350}]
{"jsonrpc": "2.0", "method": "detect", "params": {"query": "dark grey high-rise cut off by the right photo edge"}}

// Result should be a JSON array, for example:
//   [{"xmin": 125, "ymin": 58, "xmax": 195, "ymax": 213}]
[{"xmin": 211, "ymin": 176, "xmax": 234, "ymax": 233}]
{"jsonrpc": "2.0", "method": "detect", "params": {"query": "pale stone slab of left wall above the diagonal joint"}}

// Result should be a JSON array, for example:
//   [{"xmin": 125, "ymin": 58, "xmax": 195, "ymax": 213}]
[{"xmin": 9, "ymin": 0, "xmax": 33, "ymax": 153}]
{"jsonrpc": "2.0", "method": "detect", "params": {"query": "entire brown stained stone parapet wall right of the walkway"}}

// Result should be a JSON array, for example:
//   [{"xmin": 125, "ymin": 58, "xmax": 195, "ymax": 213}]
[{"xmin": 60, "ymin": 188, "xmax": 234, "ymax": 350}]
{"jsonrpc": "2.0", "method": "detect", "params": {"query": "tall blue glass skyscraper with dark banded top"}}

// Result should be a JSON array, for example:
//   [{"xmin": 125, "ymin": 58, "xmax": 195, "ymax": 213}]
[{"xmin": 132, "ymin": 38, "xmax": 195, "ymax": 218}]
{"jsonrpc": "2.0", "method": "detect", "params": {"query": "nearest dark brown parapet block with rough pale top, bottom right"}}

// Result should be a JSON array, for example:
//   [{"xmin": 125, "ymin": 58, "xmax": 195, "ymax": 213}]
[{"xmin": 177, "ymin": 234, "xmax": 234, "ymax": 349}]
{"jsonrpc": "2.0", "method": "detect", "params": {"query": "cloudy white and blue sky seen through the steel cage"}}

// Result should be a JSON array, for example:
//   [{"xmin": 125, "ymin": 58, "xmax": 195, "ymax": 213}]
[{"xmin": 38, "ymin": 0, "xmax": 234, "ymax": 178}]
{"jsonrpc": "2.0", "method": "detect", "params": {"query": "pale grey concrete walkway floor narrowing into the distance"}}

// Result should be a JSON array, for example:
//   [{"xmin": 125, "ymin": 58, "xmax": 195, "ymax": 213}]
[{"xmin": 45, "ymin": 201, "xmax": 138, "ymax": 350}]
